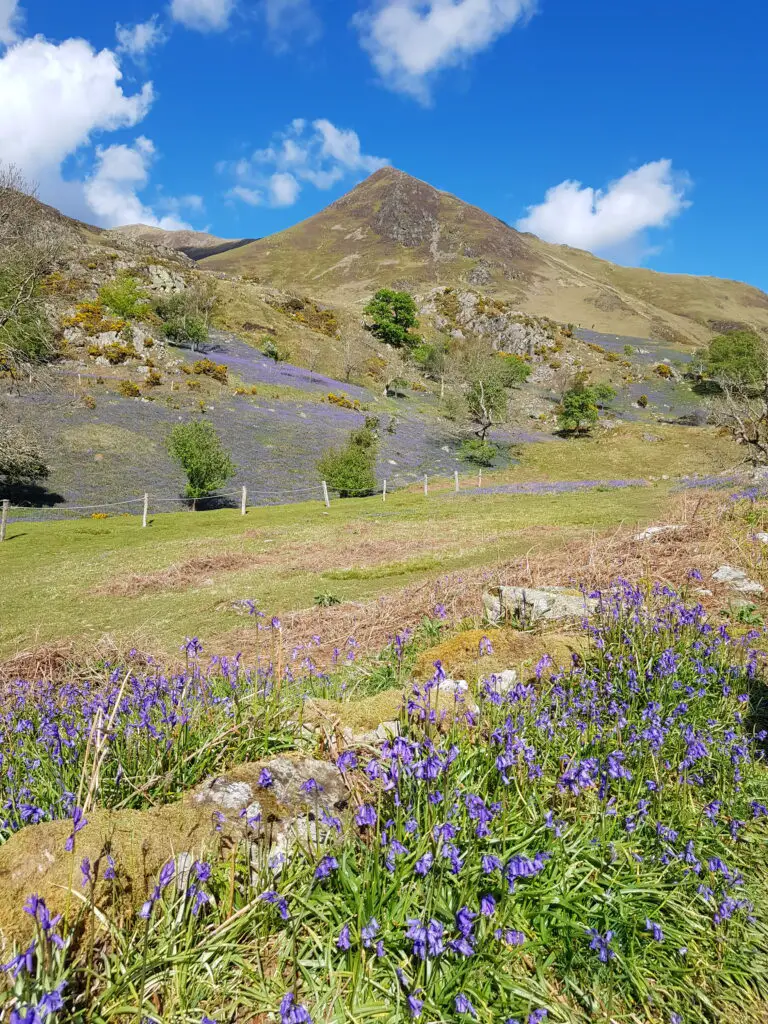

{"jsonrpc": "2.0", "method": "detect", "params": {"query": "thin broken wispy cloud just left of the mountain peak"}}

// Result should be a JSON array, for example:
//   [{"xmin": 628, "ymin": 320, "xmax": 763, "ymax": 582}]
[{"xmin": 224, "ymin": 118, "xmax": 389, "ymax": 206}]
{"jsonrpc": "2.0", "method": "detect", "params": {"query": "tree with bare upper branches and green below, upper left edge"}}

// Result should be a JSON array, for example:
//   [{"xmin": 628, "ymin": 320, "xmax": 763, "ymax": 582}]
[{"xmin": 0, "ymin": 165, "xmax": 66, "ymax": 373}]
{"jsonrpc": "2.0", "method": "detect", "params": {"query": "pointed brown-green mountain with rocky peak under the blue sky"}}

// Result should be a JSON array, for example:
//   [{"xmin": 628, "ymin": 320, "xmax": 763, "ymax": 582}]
[{"xmin": 203, "ymin": 167, "xmax": 768, "ymax": 344}]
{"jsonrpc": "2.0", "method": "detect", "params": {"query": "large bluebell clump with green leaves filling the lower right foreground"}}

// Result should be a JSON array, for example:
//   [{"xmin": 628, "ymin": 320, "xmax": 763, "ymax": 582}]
[{"xmin": 4, "ymin": 583, "xmax": 768, "ymax": 1024}]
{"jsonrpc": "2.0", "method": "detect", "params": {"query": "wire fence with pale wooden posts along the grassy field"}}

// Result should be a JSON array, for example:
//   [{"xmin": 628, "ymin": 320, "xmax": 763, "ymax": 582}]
[{"xmin": 0, "ymin": 470, "xmax": 648, "ymax": 541}]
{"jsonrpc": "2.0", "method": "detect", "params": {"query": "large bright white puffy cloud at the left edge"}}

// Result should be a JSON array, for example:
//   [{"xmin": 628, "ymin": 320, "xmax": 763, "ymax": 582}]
[{"xmin": 0, "ymin": 36, "xmax": 153, "ymax": 177}]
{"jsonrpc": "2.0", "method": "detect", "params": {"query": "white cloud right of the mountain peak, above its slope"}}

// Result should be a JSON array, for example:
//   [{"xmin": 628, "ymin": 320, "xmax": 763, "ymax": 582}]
[{"xmin": 516, "ymin": 160, "xmax": 690, "ymax": 258}]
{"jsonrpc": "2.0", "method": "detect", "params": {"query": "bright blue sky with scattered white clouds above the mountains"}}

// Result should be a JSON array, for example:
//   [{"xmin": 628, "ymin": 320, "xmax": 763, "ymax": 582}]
[{"xmin": 0, "ymin": 0, "xmax": 768, "ymax": 289}]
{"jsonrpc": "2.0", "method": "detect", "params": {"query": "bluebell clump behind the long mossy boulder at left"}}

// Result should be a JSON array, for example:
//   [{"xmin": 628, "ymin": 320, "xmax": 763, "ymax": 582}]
[{"xmin": 0, "ymin": 638, "xmax": 346, "ymax": 849}]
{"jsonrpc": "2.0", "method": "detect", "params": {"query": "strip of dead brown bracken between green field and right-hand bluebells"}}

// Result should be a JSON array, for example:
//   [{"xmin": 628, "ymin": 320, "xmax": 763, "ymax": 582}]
[{"xmin": 218, "ymin": 493, "xmax": 768, "ymax": 664}]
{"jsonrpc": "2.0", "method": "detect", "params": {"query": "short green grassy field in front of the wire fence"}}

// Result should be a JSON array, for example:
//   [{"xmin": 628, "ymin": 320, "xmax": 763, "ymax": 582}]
[{"xmin": 0, "ymin": 477, "xmax": 667, "ymax": 656}]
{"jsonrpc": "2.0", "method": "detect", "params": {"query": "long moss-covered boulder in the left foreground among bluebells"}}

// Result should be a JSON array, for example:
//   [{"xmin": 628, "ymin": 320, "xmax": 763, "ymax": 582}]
[{"xmin": 0, "ymin": 754, "xmax": 348, "ymax": 946}]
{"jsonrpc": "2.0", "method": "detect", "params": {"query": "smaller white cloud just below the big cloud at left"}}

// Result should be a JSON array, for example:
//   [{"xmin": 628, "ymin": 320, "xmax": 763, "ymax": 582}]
[{"xmin": 83, "ymin": 135, "xmax": 192, "ymax": 230}]
